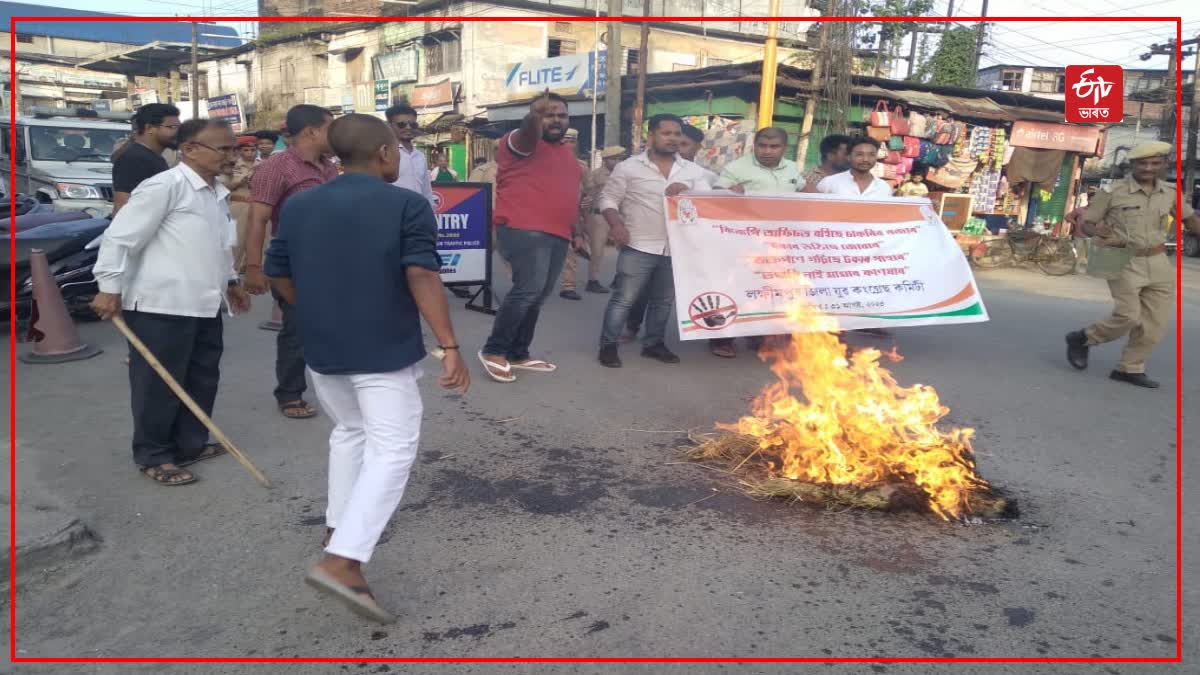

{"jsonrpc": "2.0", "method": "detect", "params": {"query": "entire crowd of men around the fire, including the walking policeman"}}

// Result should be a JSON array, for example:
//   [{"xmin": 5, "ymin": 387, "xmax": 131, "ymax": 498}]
[{"xmin": 92, "ymin": 92, "xmax": 1200, "ymax": 621}]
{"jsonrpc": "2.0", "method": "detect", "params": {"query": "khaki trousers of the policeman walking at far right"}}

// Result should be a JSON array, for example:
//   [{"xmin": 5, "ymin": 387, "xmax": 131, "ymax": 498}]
[{"xmin": 1084, "ymin": 253, "xmax": 1175, "ymax": 374}]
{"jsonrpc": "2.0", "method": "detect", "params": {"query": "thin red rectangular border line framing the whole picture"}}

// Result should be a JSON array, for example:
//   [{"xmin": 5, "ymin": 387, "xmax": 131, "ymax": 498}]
[{"xmin": 8, "ymin": 16, "xmax": 1183, "ymax": 663}]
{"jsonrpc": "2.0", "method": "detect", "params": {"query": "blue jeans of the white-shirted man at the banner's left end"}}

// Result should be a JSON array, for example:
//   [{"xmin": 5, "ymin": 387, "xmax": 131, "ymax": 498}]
[{"xmin": 600, "ymin": 247, "xmax": 674, "ymax": 347}]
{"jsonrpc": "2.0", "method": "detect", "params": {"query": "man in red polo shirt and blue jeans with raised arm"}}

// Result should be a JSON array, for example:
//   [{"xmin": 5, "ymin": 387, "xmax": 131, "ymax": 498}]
[{"xmin": 479, "ymin": 91, "xmax": 583, "ymax": 382}]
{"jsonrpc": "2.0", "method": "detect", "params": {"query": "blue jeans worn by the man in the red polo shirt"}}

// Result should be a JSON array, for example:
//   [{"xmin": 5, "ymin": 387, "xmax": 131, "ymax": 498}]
[{"xmin": 484, "ymin": 225, "xmax": 570, "ymax": 362}]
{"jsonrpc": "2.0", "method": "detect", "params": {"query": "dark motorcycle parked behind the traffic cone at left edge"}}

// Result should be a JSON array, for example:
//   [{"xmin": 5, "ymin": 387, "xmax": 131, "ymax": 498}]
[{"xmin": 0, "ymin": 214, "xmax": 109, "ymax": 322}]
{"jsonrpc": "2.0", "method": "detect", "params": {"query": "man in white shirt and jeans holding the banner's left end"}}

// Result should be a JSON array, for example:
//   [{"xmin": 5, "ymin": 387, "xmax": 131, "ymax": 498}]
[{"xmin": 599, "ymin": 115, "xmax": 712, "ymax": 368}]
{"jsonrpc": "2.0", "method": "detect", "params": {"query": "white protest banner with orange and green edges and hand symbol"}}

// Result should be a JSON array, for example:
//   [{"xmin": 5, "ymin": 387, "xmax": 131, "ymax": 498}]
[{"xmin": 666, "ymin": 192, "xmax": 988, "ymax": 340}]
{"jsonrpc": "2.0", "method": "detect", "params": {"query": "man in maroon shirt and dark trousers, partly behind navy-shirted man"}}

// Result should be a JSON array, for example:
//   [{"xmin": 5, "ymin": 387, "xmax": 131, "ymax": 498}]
[{"xmin": 246, "ymin": 104, "xmax": 337, "ymax": 419}]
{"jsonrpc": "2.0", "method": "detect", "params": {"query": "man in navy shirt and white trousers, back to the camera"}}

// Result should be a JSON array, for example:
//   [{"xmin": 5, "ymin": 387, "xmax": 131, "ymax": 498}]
[{"xmin": 264, "ymin": 114, "xmax": 470, "ymax": 622}]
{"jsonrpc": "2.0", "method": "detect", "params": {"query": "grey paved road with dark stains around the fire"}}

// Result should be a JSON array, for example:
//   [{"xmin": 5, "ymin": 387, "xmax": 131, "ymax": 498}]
[{"xmin": 4, "ymin": 251, "xmax": 1200, "ymax": 675}]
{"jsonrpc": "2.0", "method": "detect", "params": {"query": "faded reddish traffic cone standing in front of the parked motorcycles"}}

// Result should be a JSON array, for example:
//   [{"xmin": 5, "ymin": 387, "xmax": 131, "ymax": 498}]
[{"xmin": 20, "ymin": 249, "xmax": 101, "ymax": 363}]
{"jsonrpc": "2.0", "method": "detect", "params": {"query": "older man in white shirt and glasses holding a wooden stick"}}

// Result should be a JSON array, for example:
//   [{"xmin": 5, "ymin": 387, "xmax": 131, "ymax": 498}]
[{"xmin": 92, "ymin": 119, "xmax": 250, "ymax": 485}]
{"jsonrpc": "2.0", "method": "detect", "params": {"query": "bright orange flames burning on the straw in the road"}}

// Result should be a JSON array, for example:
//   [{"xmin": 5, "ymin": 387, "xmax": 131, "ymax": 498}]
[{"xmin": 718, "ymin": 304, "xmax": 989, "ymax": 520}]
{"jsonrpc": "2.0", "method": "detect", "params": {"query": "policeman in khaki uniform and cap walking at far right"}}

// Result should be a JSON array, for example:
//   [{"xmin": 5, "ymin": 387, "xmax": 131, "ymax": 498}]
[{"xmin": 1067, "ymin": 142, "xmax": 1200, "ymax": 389}]
